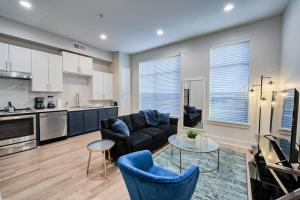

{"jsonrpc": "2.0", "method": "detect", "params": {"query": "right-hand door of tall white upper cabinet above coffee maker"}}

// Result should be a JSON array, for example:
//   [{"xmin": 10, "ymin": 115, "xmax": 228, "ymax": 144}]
[{"xmin": 49, "ymin": 54, "xmax": 63, "ymax": 92}]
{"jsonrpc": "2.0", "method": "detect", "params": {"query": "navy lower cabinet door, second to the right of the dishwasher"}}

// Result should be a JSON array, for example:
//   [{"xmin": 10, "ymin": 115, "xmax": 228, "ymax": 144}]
[{"xmin": 84, "ymin": 110, "xmax": 99, "ymax": 132}]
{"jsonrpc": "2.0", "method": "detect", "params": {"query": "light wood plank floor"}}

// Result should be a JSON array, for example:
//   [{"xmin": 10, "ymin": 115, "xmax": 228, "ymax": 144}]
[{"xmin": 0, "ymin": 132, "xmax": 251, "ymax": 200}]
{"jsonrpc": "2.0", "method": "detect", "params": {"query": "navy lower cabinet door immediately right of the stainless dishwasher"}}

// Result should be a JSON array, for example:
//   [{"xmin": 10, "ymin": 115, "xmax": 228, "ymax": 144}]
[{"xmin": 68, "ymin": 111, "xmax": 85, "ymax": 136}]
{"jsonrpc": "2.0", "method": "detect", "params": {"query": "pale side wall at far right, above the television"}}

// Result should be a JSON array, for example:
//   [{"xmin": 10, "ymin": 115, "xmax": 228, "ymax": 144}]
[{"xmin": 281, "ymin": 0, "xmax": 300, "ymax": 142}]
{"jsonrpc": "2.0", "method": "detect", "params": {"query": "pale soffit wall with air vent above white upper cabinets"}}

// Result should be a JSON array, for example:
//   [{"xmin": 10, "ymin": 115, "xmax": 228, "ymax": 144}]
[{"xmin": 0, "ymin": 16, "xmax": 113, "ymax": 62}]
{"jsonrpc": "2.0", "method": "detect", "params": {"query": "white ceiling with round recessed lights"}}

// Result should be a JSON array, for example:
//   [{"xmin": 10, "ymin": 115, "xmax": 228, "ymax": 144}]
[{"xmin": 0, "ymin": 0, "xmax": 288, "ymax": 53}]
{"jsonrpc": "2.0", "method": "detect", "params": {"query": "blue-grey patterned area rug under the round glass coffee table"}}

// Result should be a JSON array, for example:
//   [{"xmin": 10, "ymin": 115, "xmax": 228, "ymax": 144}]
[{"xmin": 154, "ymin": 147, "xmax": 247, "ymax": 200}]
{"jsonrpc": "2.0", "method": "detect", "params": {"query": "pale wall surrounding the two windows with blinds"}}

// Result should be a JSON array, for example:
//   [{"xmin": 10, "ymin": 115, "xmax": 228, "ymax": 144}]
[{"xmin": 131, "ymin": 17, "xmax": 281, "ymax": 147}]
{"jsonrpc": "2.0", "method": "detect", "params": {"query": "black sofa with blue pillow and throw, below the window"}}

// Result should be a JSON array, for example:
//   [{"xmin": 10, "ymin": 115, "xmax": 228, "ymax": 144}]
[{"xmin": 101, "ymin": 111, "xmax": 178, "ymax": 160}]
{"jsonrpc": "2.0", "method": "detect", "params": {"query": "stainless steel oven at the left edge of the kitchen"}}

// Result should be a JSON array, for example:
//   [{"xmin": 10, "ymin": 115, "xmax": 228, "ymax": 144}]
[{"xmin": 0, "ymin": 114, "xmax": 36, "ymax": 156}]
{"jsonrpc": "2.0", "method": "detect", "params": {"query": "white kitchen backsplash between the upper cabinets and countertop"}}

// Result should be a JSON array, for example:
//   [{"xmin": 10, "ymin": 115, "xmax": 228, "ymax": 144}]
[{"xmin": 0, "ymin": 74, "xmax": 111, "ymax": 110}]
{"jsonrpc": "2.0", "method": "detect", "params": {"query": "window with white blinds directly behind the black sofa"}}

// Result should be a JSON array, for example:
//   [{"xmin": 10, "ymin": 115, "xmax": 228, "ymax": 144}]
[{"xmin": 139, "ymin": 56, "xmax": 180, "ymax": 115}]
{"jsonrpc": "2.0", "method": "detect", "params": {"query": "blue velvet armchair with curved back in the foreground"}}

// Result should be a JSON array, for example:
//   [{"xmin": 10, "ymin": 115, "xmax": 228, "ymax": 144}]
[{"xmin": 118, "ymin": 150, "xmax": 199, "ymax": 200}]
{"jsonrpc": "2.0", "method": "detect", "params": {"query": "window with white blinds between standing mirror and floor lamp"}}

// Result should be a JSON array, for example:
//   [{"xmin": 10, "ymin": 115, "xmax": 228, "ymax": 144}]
[{"xmin": 209, "ymin": 41, "xmax": 250, "ymax": 123}]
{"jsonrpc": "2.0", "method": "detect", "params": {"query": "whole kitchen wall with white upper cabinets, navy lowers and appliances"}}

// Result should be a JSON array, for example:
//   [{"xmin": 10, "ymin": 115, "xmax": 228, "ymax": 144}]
[{"xmin": 0, "ymin": 41, "xmax": 118, "ymax": 156}]
